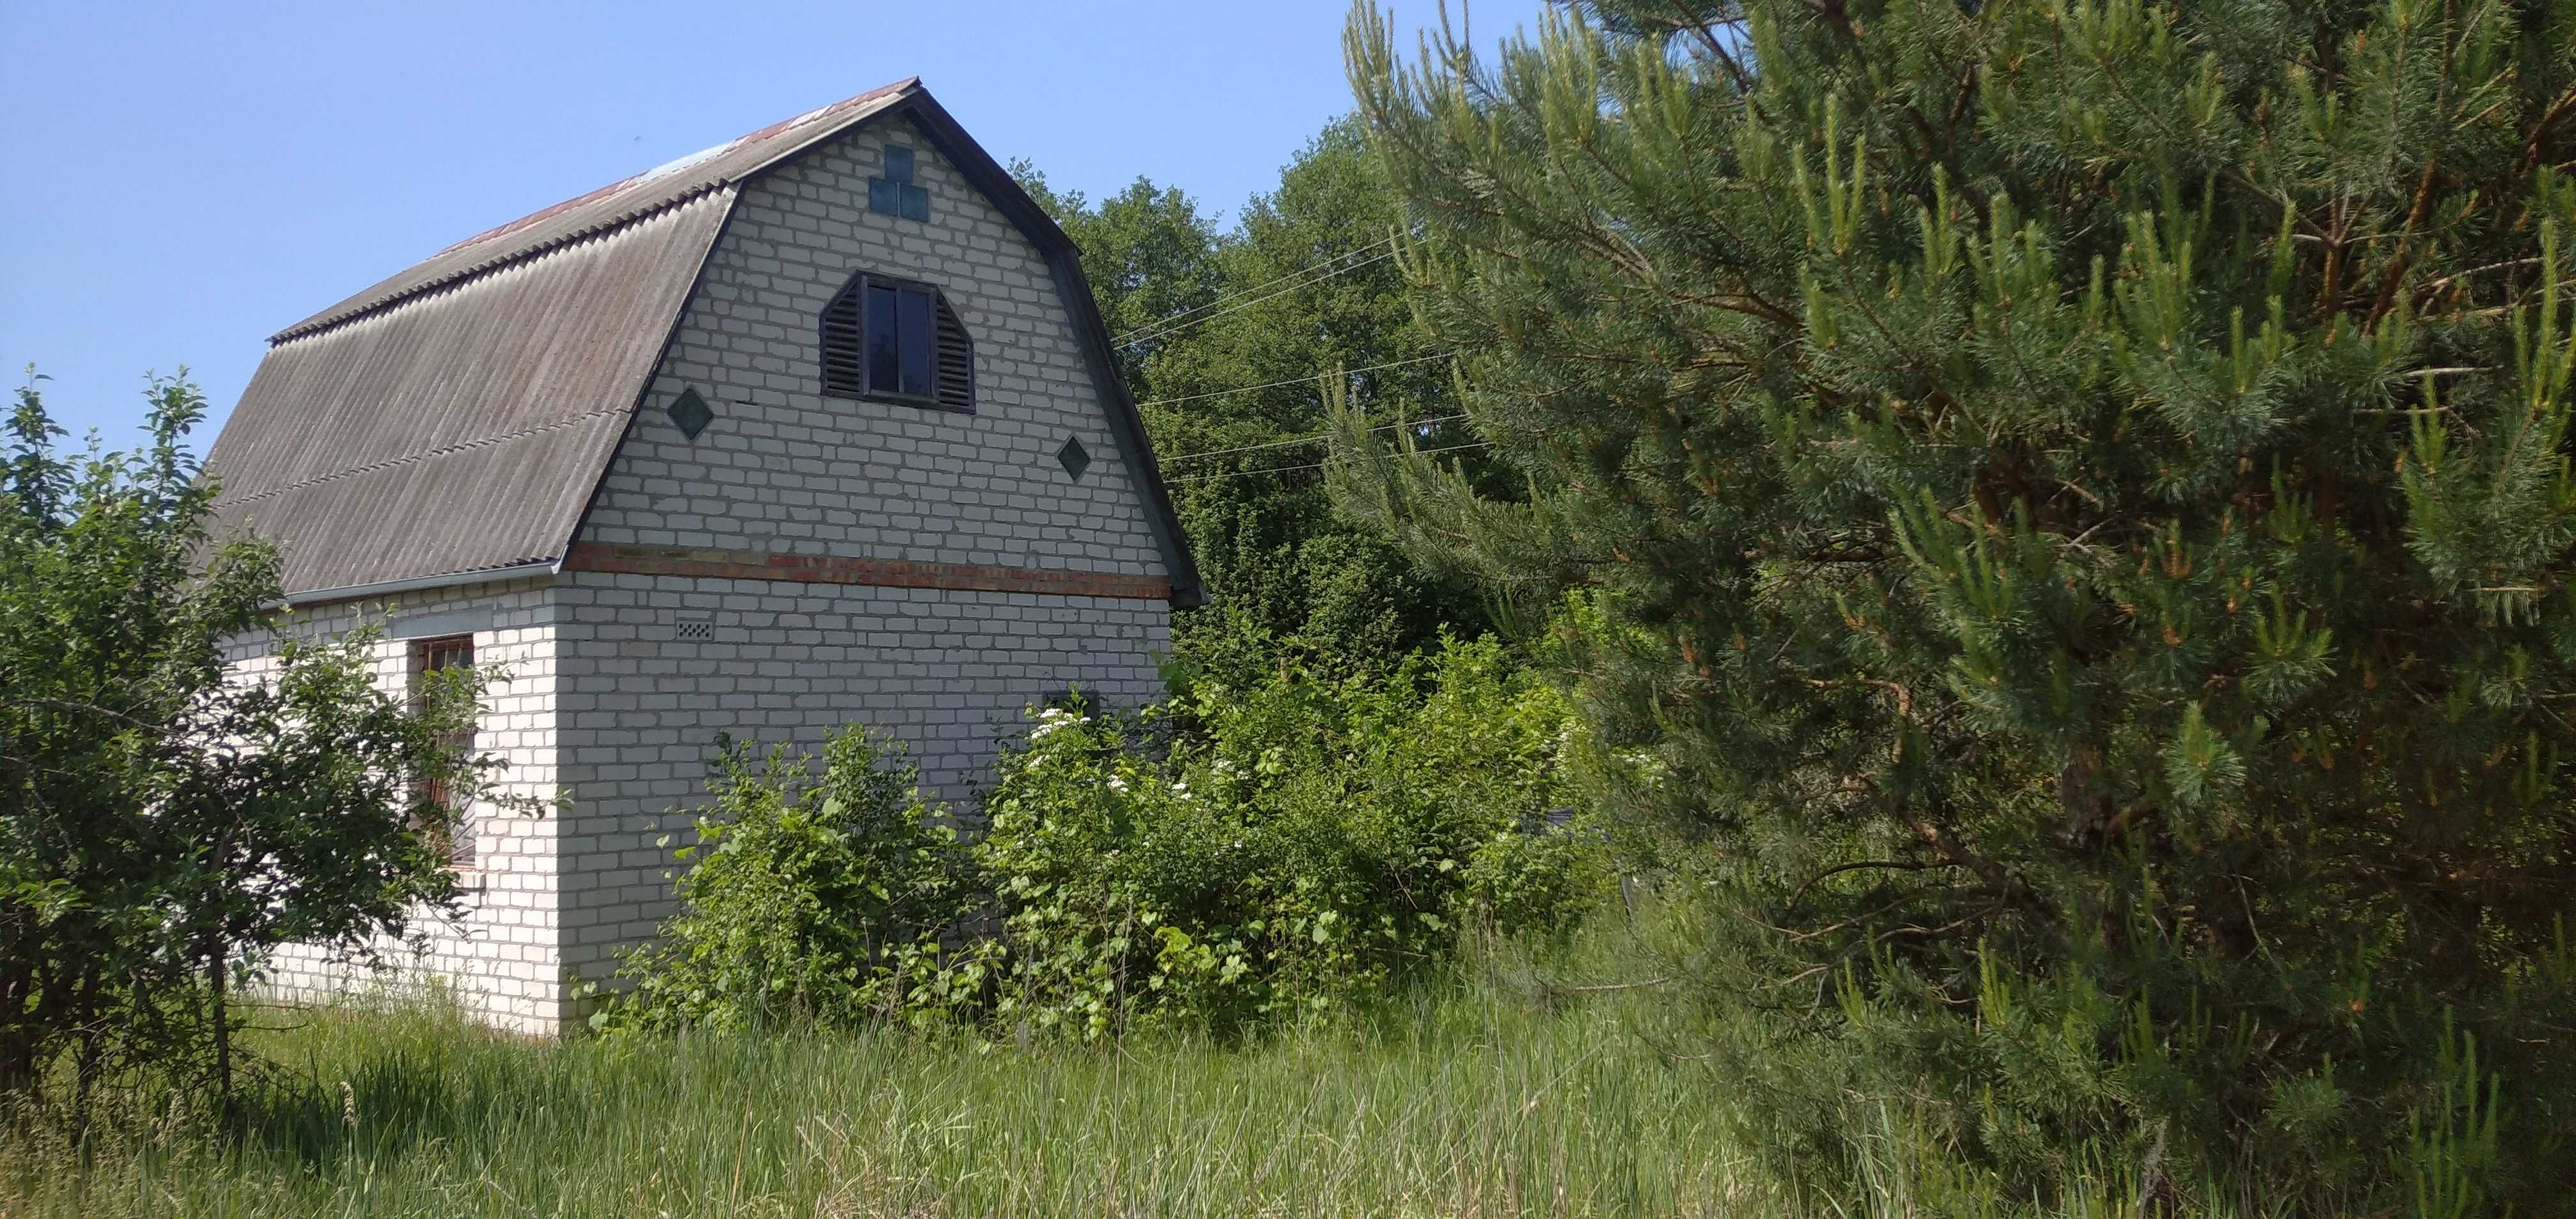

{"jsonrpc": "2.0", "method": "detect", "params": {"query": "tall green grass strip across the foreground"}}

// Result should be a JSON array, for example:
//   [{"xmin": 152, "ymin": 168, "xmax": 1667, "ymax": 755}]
[{"xmin": 0, "ymin": 974, "xmax": 1782, "ymax": 1219}]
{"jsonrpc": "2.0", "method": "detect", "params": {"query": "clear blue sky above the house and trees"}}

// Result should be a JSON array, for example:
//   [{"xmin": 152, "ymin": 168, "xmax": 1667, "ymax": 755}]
[{"xmin": 0, "ymin": 0, "xmax": 1540, "ymax": 448}]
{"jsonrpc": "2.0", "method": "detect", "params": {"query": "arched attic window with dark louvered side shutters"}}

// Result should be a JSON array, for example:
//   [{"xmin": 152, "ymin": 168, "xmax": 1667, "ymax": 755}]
[{"xmin": 822, "ymin": 271, "xmax": 974, "ymax": 415}]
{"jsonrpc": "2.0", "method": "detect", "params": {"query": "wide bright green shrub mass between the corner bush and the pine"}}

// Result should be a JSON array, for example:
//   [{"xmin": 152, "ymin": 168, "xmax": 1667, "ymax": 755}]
[{"xmin": 976, "ymin": 639, "xmax": 1600, "ymax": 1036}]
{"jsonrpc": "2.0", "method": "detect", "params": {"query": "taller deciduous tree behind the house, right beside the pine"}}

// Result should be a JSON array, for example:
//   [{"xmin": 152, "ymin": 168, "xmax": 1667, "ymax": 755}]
[{"xmin": 1141, "ymin": 119, "xmax": 1489, "ymax": 668}]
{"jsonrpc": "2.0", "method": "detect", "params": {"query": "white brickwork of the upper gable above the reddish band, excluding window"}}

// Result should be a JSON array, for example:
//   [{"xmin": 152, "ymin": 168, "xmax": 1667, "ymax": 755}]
[{"xmin": 585, "ymin": 124, "xmax": 1164, "ymax": 575}]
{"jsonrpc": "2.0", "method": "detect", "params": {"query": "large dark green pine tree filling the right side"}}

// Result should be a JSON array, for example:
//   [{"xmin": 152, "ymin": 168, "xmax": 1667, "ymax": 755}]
[{"xmin": 1337, "ymin": 0, "xmax": 2576, "ymax": 1214}]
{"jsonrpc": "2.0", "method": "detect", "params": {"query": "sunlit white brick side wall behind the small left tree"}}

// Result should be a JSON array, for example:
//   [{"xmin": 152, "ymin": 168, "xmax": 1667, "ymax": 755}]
[{"xmin": 229, "ymin": 580, "xmax": 567, "ymax": 1034}]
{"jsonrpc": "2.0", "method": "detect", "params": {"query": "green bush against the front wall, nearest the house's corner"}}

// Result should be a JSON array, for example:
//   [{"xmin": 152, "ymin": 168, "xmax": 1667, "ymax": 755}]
[{"xmin": 590, "ymin": 727, "xmax": 966, "ymax": 1031}]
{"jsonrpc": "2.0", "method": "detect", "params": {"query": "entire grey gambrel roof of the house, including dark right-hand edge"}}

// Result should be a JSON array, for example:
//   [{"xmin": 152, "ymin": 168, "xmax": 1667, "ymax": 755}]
[{"xmin": 206, "ymin": 80, "xmax": 1203, "ymax": 606}]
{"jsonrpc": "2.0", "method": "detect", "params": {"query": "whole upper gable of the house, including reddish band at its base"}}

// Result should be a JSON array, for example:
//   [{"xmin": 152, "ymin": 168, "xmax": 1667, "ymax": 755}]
[{"xmin": 567, "ymin": 98, "xmax": 1198, "ymax": 603}]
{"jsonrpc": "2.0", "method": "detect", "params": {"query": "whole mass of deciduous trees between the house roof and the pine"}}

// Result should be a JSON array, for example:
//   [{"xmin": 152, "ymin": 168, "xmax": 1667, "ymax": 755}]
[{"xmin": 1015, "ymin": 121, "xmax": 1489, "ymax": 680}]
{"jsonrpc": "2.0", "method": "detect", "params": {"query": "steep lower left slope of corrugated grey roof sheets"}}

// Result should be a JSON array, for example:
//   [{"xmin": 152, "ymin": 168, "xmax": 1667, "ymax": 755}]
[{"xmin": 206, "ymin": 188, "xmax": 734, "ymax": 595}]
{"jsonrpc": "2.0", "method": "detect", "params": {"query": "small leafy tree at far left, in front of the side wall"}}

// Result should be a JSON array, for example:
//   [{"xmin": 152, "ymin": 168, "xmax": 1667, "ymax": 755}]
[{"xmin": 0, "ymin": 381, "xmax": 526, "ymax": 1119}]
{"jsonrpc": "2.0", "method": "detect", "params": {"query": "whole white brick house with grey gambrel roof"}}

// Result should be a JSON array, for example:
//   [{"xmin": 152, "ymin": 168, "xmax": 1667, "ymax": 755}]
[{"xmin": 206, "ymin": 80, "xmax": 1200, "ymax": 1034}]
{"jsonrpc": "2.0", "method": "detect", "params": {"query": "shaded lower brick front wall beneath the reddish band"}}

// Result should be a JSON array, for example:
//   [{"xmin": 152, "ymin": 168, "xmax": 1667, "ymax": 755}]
[{"xmin": 556, "ymin": 572, "xmax": 1170, "ymax": 977}]
